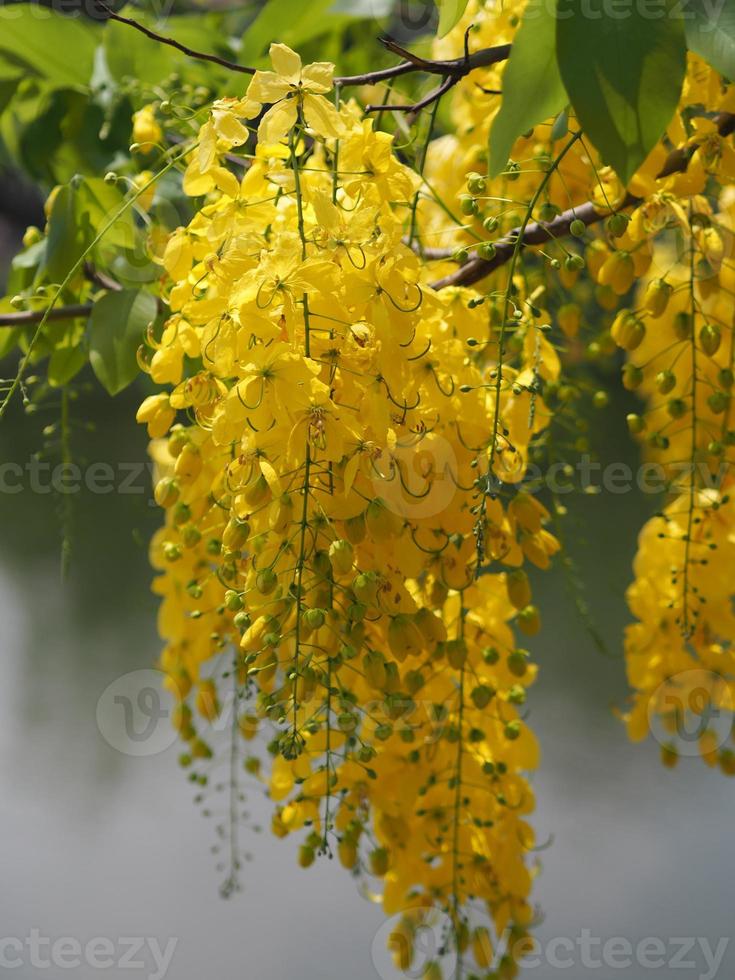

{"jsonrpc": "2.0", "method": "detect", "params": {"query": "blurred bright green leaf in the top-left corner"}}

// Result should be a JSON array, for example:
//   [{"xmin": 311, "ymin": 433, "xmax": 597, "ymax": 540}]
[{"xmin": 0, "ymin": 3, "xmax": 98, "ymax": 89}]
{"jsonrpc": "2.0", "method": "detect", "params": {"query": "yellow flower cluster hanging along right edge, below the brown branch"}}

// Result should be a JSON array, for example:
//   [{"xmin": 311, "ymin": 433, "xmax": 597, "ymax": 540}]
[{"xmin": 613, "ymin": 192, "xmax": 735, "ymax": 775}]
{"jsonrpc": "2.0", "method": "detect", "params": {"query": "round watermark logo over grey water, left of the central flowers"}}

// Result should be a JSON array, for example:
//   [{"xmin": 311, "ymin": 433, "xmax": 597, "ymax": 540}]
[{"xmin": 97, "ymin": 669, "xmax": 178, "ymax": 757}]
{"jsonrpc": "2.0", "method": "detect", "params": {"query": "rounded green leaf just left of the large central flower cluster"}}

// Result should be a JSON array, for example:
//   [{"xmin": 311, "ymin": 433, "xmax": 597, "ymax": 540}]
[{"xmin": 89, "ymin": 289, "xmax": 157, "ymax": 395}]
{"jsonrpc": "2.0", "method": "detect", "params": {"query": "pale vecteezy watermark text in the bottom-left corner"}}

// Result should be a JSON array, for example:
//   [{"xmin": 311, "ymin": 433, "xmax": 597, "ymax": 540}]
[{"xmin": 0, "ymin": 929, "xmax": 178, "ymax": 980}]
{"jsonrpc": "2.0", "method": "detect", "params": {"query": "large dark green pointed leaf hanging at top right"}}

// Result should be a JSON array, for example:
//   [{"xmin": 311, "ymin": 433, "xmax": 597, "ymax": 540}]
[{"xmin": 556, "ymin": 0, "xmax": 686, "ymax": 183}]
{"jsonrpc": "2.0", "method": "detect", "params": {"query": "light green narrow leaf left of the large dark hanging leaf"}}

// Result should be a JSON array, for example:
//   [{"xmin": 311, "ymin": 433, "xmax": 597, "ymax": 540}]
[{"xmin": 490, "ymin": 0, "xmax": 568, "ymax": 177}]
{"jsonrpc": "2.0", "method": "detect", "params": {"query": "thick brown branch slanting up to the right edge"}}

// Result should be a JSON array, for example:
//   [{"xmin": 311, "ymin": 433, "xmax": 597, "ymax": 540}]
[{"xmin": 432, "ymin": 112, "xmax": 735, "ymax": 289}]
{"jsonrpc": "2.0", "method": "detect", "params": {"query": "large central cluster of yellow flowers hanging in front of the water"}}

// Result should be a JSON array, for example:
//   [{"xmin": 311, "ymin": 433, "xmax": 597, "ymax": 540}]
[{"xmin": 138, "ymin": 45, "xmax": 558, "ymax": 975}]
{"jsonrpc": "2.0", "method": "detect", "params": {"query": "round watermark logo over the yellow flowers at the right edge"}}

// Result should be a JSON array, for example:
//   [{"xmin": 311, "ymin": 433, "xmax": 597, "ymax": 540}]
[{"xmin": 648, "ymin": 668, "xmax": 735, "ymax": 758}]
